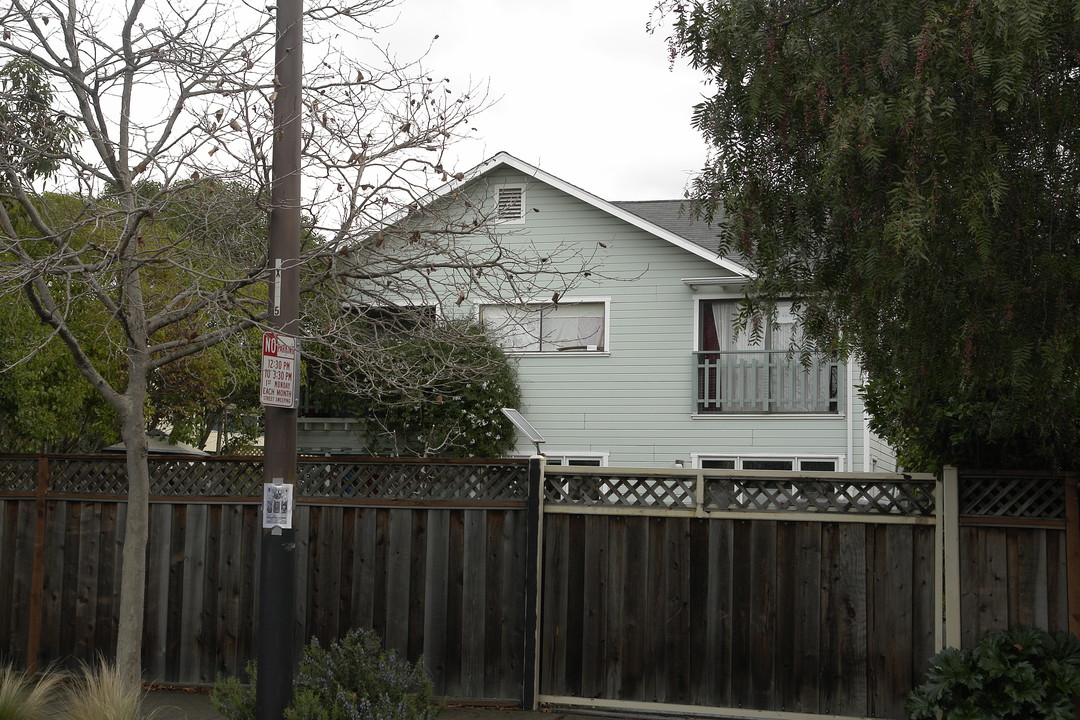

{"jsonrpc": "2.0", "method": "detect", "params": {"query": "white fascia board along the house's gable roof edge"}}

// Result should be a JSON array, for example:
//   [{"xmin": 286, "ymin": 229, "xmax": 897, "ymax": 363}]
[{"xmin": 373, "ymin": 152, "xmax": 751, "ymax": 277}]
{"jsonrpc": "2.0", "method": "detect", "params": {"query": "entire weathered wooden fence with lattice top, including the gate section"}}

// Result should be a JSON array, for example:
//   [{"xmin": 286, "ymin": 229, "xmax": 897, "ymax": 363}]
[{"xmin": 0, "ymin": 456, "xmax": 1080, "ymax": 719}]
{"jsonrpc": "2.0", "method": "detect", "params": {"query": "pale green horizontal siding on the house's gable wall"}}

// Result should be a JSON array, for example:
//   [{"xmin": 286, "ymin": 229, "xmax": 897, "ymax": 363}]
[{"xmin": 447, "ymin": 168, "xmax": 862, "ymax": 470}]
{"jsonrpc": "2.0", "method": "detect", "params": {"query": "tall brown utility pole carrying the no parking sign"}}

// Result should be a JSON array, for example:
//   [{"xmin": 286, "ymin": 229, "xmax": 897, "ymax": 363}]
[{"xmin": 255, "ymin": 0, "xmax": 303, "ymax": 720}]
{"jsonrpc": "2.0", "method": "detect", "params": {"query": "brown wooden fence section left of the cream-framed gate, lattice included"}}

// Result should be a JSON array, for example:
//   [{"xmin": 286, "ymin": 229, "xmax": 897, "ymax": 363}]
[{"xmin": 0, "ymin": 458, "xmax": 527, "ymax": 702}]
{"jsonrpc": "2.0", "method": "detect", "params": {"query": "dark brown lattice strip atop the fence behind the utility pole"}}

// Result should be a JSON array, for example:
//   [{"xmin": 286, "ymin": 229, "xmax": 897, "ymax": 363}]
[{"xmin": 0, "ymin": 457, "xmax": 528, "ymax": 502}]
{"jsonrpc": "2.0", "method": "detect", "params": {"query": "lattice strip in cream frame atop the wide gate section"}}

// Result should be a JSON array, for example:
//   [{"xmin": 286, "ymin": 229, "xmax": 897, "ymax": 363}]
[{"xmin": 544, "ymin": 468, "xmax": 934, "ymax": 516}]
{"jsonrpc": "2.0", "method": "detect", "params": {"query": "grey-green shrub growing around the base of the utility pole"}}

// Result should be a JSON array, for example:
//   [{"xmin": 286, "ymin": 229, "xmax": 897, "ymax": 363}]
[{"xmin": 211, "ymin": 629, "xmax": 438, "ymax": 720}]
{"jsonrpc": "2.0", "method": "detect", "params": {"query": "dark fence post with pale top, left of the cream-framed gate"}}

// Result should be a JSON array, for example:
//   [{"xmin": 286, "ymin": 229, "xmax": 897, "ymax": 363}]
[{"xmin": 522, "ymin": 454, "xmax": 544, "ymax": 710}]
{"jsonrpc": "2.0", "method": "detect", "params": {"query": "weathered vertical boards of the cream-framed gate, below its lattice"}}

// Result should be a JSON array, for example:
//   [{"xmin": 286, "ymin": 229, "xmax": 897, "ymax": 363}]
[{"xmin": 541, "ymin": 514, "xmax": 934, "ymax": 719}]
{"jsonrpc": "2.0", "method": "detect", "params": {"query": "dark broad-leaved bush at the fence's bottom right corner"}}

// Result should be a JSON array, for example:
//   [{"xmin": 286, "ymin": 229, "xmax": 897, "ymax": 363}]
[{"xmin": 907, "ymin": 626, "xmax": 1080, "ymax": 720}]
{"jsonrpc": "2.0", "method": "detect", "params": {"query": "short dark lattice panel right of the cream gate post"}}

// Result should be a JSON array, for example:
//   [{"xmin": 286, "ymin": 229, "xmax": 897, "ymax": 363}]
[{"xmin": 960, "ymin": 473, "xmax": 1065, "ymax": 520}]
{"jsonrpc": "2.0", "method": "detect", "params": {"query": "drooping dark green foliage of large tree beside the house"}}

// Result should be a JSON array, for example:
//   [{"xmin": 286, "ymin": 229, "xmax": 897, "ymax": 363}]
[{"xmin": 661, "ymin": 0, "xmax": 1080, "ymax": 468}]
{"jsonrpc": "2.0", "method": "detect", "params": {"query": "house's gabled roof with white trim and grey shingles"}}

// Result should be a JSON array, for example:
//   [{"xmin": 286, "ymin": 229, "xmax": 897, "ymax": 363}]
[{"xmin": 432, "ymin": 152, "xmax": 751, "ymax": 277}]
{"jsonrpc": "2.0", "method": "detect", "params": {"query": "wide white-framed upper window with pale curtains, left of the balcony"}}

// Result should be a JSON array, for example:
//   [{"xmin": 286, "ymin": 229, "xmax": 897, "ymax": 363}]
[{"xmin": 481, "ymin": 300, "xmax": 608, "ymax": 353}]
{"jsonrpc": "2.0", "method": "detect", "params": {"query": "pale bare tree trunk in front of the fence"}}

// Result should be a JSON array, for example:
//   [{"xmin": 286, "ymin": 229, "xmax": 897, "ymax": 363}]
[{"xmin": 117, "ymin": 388, "xmax": 150, "ymax": 687}]
